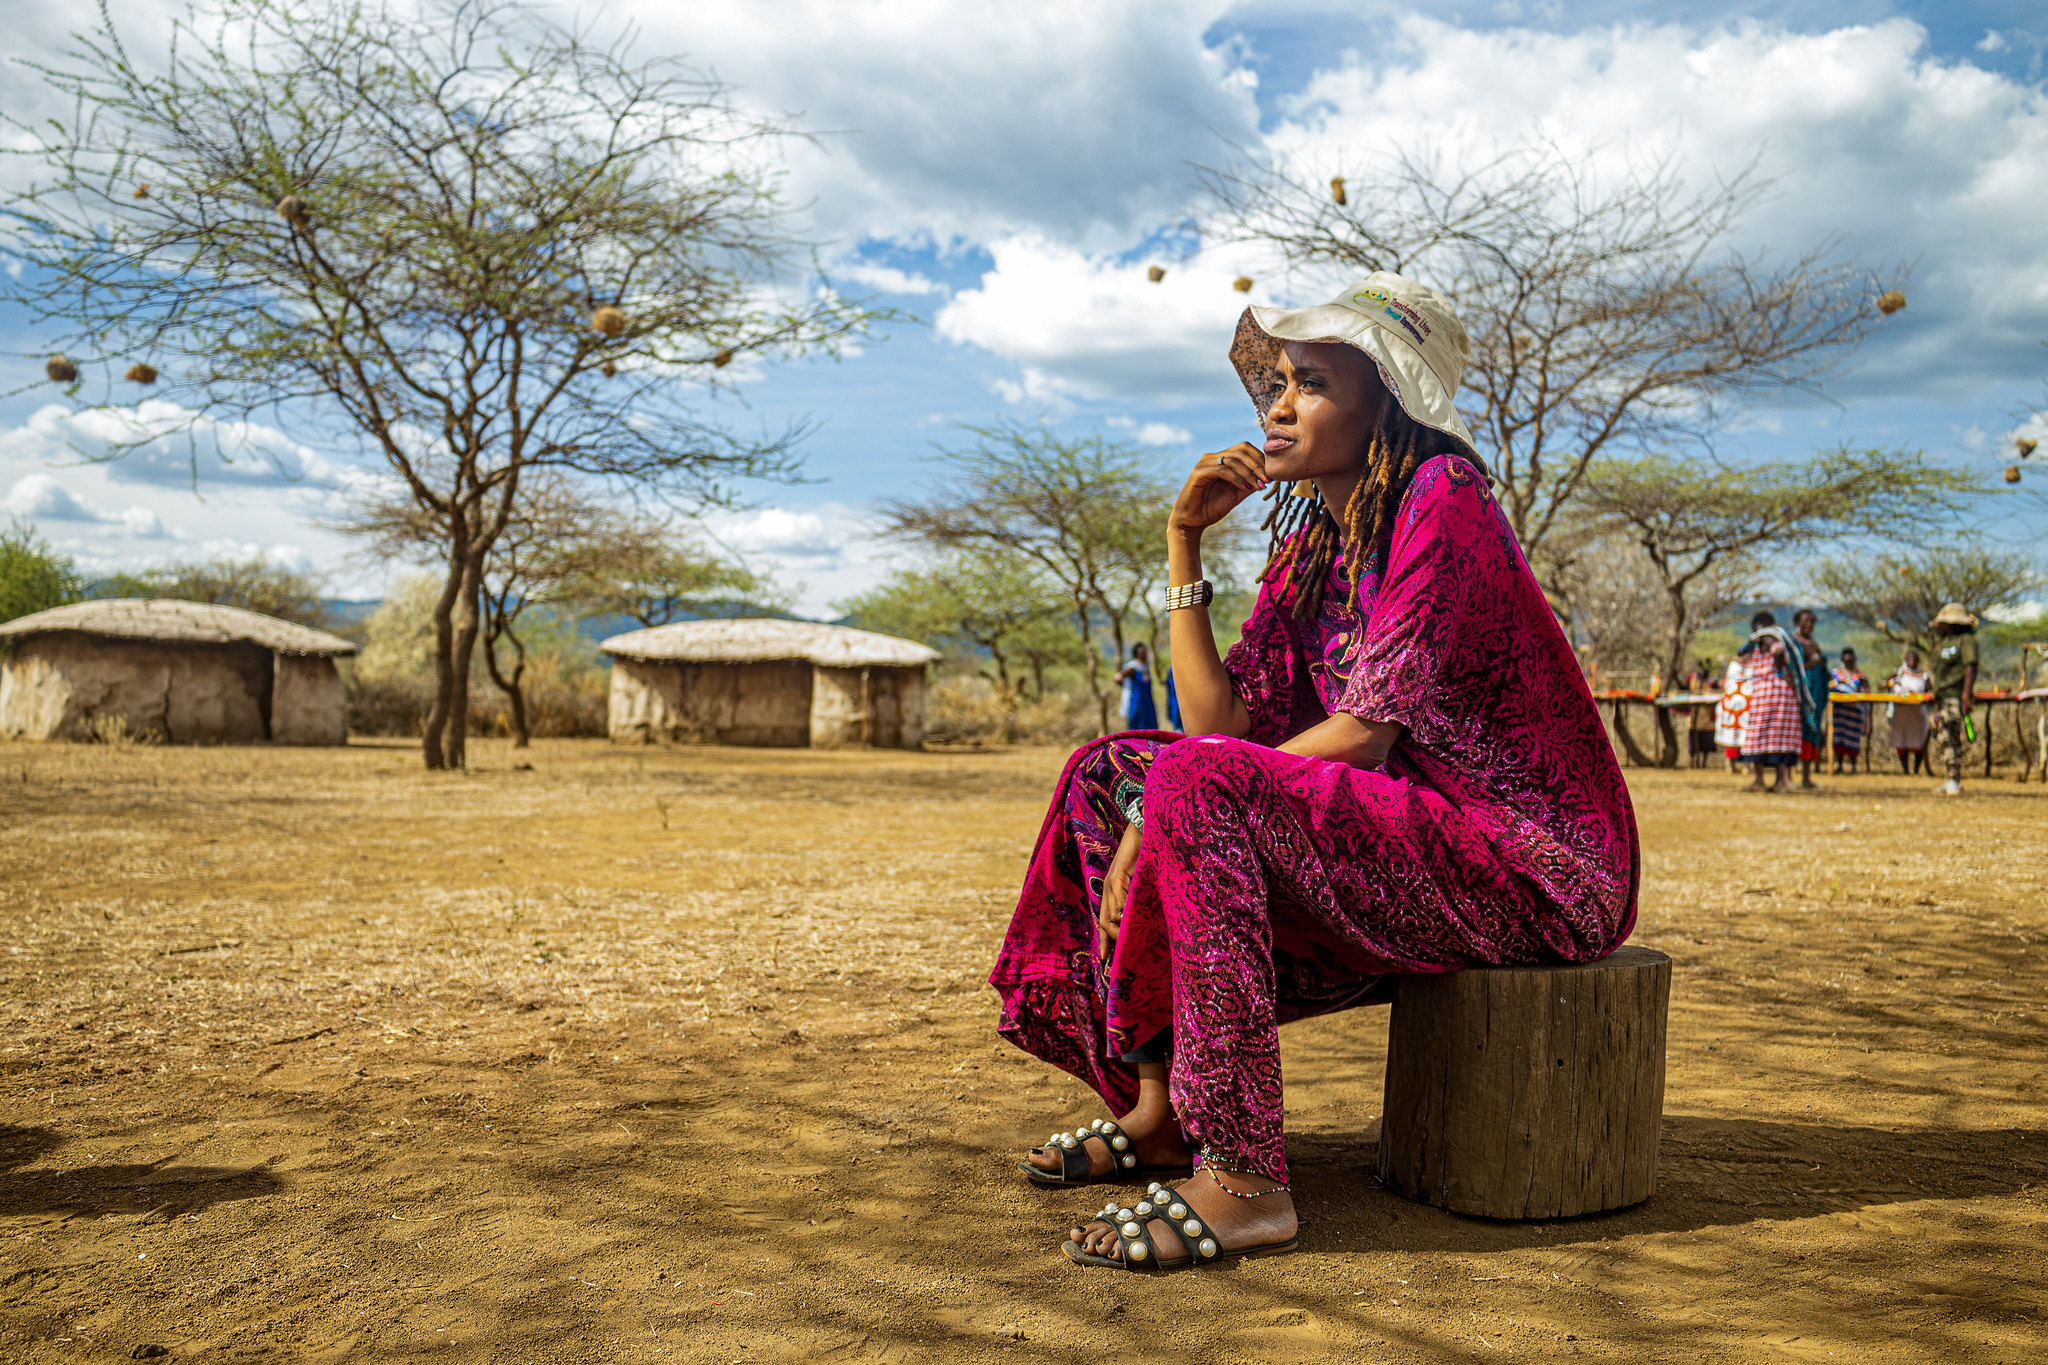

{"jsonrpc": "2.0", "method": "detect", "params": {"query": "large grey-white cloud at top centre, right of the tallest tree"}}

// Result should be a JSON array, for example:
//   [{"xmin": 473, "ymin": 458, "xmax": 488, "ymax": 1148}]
[{"xmin": 608, "ymin": 0, "xmax": 1257, "ymax": 250}]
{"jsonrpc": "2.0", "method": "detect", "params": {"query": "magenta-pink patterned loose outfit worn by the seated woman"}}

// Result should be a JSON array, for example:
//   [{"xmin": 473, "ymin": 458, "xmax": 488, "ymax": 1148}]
[{"xmin": 989, "ymin": 456, "xmax": 1638, "ymax": 1181}]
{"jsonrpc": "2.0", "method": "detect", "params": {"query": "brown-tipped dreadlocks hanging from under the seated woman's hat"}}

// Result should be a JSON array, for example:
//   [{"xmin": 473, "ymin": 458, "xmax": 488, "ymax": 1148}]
[{"xmin": 1260, "ymin": 395, "xmax": 1473, "ymax": 620}]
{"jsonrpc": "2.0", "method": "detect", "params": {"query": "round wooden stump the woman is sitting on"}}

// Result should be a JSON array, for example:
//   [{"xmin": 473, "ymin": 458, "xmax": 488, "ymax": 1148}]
[{"xmin": 1380, "ymin": 945, "xmax": 1671, "ymax": 1218}]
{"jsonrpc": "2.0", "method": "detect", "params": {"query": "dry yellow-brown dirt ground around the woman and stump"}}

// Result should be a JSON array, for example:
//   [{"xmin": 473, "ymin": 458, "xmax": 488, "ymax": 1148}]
[{"xmin": 0, "ymin": 741, "xmax": 2048, "ymax": 1365}]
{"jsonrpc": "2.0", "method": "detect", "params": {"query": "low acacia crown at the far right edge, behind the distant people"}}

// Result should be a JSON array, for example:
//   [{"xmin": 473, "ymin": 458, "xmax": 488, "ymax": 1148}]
[{"xmin": 1810, "ymin": 540, "xmax": 2048, "ymax": 653}]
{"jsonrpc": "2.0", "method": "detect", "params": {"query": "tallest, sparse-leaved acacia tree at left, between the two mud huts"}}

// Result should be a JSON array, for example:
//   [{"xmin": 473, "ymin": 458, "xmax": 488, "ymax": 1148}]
[{"xmin": 6, "ymin": 0, "xmax": 872, "ymax": 767}]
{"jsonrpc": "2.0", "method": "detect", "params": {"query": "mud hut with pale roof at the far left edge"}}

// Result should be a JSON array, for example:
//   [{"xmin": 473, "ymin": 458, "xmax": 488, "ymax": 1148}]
[{"xmin": 0, "ymin": 598, "xmax": 356, "ymax": 745}]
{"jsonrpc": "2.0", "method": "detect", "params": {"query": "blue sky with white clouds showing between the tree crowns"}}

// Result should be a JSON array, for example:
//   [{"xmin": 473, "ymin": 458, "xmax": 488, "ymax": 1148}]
[{"xmin": 0, "ymin": 0, "xmax": 2048, "ymax": 610}]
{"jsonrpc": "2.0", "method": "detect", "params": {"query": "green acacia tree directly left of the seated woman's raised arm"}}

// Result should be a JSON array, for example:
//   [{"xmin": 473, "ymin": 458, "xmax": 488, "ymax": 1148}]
[{"xmin": 881, "ymin": 424, "xmax": 1204, "ymax": 733}]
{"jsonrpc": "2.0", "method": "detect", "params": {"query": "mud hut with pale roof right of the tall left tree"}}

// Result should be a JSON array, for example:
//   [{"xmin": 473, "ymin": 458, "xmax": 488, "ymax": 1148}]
[{"xmin": 598, "ymin": 620, "xmax": 938, "ymax": 749}]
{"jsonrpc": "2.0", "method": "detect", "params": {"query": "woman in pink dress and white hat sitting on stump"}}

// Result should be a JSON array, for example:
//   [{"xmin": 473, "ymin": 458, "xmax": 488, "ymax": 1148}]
[{"xmin": 991, "ymin": 274, "xmax": 1638, "ymax": 1271}]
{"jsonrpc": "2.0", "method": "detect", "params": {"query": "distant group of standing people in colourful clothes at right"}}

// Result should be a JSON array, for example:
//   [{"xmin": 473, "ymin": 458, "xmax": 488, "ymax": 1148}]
[{"xmin": 1690, "ymin": 602, "xmax": 1978, "ymax": 796}]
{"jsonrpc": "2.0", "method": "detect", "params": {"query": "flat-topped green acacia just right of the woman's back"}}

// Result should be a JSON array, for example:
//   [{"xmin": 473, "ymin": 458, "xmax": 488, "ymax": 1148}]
[{"xmin": 1552, "ymin": 446, "xmax": 1978, "ymax": 767}]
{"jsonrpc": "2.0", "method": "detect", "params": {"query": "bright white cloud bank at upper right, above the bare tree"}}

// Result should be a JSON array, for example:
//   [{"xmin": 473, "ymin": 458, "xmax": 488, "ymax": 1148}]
[{"xmin": 1270, "ymin": 14, "xmax": 2048, "ymax": 397}]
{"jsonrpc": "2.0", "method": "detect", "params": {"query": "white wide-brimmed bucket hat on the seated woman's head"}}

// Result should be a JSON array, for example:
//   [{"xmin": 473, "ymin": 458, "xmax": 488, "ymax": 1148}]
[{"xmin": 1231, "ymin": 270, "xmax": 1473, "ymax": 448}]
